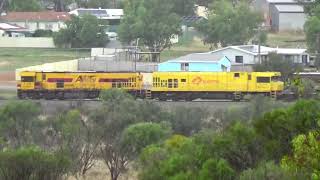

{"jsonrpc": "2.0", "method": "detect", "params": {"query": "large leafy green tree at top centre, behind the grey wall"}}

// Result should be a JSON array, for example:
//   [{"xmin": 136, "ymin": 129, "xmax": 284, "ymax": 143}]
[{"xmin": 118, "ymin": 0, "xmax": 181, "ymax": 52}]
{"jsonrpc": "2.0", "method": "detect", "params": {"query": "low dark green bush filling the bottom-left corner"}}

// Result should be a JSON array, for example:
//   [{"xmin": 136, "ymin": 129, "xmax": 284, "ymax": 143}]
[{"xmin": 0, "ymin": 147, "xmax": 70, "ymax": 180}]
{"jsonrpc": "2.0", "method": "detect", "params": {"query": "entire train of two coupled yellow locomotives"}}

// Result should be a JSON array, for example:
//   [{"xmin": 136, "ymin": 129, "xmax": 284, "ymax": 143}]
[{"xmin": 18, "ymin": 72, "xmax": 284, "ymax": 100}]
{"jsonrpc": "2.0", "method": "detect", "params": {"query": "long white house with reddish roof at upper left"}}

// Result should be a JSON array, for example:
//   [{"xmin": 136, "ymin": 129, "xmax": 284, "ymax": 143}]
[{"xmin": 0, "ymin": 11, "xmax": 70, "ymax": 32}]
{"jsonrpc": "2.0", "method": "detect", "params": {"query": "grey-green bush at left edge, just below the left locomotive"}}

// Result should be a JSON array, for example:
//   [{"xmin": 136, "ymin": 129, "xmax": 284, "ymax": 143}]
[{"xmin": 0, "ymin": 101, "xmax": 40, "ymax": 147}]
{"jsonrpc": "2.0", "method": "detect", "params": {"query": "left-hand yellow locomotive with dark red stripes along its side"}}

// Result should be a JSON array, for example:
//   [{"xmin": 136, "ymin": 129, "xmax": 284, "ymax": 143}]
[{"xmin": 18, "ymin": 72, "xmax": 143, "ymax": 99}]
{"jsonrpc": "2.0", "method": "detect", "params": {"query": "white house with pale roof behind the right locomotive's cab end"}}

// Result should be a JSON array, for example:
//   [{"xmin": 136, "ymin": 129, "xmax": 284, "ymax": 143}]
[{"xmin": 206, "ymin": 45, "xmax": 310, "ymax": 65}]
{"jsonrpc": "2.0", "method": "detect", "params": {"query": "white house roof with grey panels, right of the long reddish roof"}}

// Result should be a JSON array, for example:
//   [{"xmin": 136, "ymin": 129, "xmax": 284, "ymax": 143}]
[{"xmin": 69, "ymin": 8, "xmax": 123, "ymax": 19}]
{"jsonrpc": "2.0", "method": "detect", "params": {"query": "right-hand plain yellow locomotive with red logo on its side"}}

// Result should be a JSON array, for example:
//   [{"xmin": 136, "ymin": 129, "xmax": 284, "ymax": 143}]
[{"xmin": 152, "ymin": 72, "xmax": 284, "ymax": 100}]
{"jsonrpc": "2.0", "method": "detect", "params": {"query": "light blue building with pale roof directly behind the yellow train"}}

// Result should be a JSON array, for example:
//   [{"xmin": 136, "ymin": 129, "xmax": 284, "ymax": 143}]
[{"xmin": 158, "ymin": 53, "xmax": 231, "ymax": 72}]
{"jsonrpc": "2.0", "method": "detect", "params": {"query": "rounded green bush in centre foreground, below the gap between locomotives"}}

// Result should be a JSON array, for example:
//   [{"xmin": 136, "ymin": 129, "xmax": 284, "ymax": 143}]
[{"xmin": 121, "ymin": 123, "xmax": 171, "ymax": 158}]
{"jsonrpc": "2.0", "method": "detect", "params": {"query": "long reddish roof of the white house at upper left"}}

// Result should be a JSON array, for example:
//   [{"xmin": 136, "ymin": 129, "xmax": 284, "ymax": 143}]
[{"xmin": 0, "ymin": 11, "xmax": 70, "ymax": 22}]
